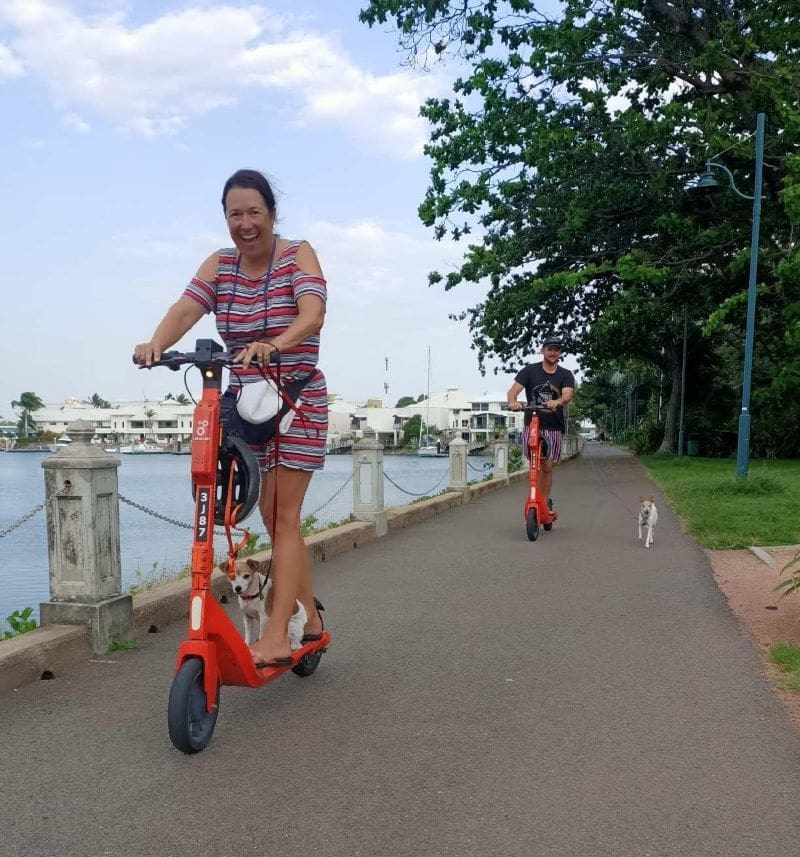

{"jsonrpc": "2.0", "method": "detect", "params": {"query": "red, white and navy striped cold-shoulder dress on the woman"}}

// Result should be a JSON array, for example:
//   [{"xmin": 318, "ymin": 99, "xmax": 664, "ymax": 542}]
[{"xmin": 183, "ymin": 241, "xmax": 328, "ymax": 471}]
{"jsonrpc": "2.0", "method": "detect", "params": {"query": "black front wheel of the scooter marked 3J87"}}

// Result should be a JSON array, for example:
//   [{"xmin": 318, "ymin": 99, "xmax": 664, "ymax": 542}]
[{"xmin": 167, "ymin": 658, "xmax": 219, "ymax": 753}]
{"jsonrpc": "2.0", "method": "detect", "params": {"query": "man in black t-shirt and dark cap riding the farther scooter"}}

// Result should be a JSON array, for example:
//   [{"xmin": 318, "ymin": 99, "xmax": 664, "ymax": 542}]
[{"xmin": 508, "ymin": 335, "xmax": 575, "ymax": 518}]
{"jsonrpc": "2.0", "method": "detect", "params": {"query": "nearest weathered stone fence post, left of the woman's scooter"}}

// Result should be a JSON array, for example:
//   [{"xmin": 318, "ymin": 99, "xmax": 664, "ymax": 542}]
[{"xmin": 40, "ymin": 420, "xmax": 133, "ymax": 654}]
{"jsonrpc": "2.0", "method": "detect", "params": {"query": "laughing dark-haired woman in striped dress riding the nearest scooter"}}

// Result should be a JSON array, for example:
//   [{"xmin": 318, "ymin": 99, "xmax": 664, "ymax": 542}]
[{"xmin": 134, "ymin": 170, "xmax": 328, "ymax": 665}]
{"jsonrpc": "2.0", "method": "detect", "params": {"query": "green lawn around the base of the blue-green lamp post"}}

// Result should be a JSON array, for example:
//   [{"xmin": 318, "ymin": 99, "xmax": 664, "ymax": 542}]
[{"xmin": 639, "ymin": 455, "xmax": 800, "ymax": 550}]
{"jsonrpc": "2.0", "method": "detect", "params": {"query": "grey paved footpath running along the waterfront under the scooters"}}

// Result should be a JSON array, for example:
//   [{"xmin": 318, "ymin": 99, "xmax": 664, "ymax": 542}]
[{"xmin": 0, "ymin": 444, "xmax": 800, "ymax": 857}]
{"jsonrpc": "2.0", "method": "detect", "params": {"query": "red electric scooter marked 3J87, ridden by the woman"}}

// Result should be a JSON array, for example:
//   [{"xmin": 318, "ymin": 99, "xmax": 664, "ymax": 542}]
[{"xmin": 134, "ymin": 339, "xmax": 330, "ymax": 753}]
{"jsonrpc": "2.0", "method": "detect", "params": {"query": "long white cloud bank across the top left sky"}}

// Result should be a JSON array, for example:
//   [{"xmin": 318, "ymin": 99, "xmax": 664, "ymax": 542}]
[{"xmin": 0, "ymin": 0, "xmax": 437, "ymax": 157}]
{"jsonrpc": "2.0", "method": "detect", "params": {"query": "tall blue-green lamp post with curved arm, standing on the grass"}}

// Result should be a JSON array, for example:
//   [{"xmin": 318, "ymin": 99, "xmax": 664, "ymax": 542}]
[{"xmin": 696, "ymin": 113, "xmax": 764, "ymax": 479}]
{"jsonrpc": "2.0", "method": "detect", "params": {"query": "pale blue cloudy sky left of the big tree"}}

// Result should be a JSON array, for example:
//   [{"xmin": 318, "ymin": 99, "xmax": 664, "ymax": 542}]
[{"xmin": 0, "ymin": 0, "xmax": 576, "ymax": 418}]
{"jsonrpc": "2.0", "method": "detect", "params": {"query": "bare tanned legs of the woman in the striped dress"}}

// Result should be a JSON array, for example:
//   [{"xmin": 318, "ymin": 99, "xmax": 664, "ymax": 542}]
[{"xmin": 250, "ymin": 466, "xmax": 322, "ymax": 661}]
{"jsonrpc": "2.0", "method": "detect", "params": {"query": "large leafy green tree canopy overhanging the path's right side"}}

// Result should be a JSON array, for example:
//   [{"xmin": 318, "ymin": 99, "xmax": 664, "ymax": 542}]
[{"xmin": 361, "ymin": 0, "xmax": 800, "ymax": 454}]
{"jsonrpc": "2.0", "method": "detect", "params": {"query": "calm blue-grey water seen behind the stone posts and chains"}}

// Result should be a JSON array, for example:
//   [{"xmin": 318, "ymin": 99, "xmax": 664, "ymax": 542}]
[{"xmin": 0, "ymin": 453, "xmax": 491, "ymax": 617}]
